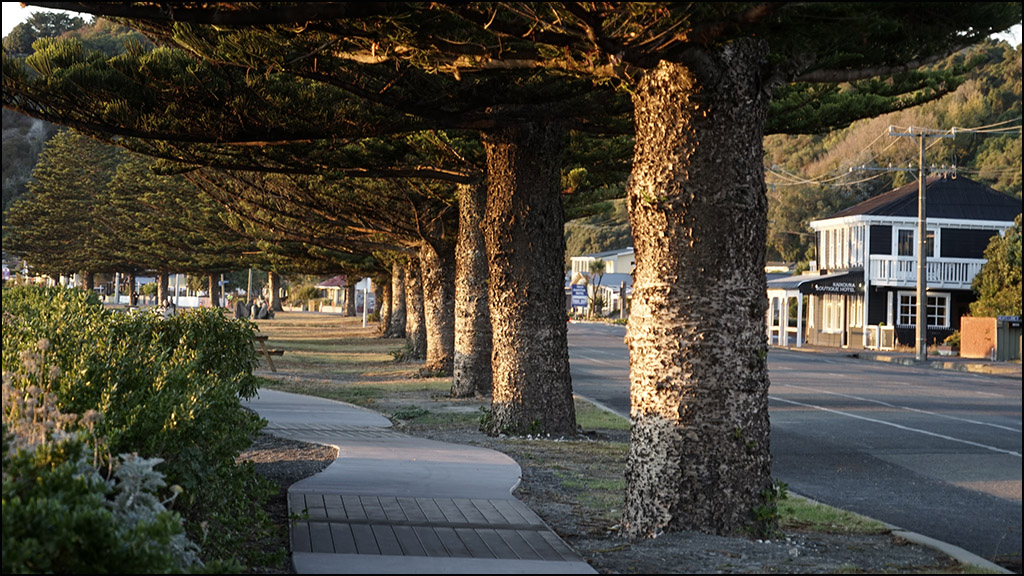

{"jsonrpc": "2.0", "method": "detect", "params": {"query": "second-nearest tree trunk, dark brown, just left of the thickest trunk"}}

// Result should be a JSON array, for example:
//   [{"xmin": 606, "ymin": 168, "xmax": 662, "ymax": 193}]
[{"xmin": 483, "ymin": 123, "xmax": 577, "ymax": 436}]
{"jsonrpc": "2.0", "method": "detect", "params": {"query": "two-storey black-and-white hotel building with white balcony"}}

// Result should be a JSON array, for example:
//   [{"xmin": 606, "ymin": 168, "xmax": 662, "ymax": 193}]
[{"xmin": 768, "ymin": 176, "xmax": 1021, "ymax": 348}]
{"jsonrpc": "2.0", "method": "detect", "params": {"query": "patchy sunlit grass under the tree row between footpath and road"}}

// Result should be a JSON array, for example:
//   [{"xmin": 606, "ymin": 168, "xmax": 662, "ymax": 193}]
[{"xmin": 249, "ymin": 313, "xmax": 913, "ymax": 534}]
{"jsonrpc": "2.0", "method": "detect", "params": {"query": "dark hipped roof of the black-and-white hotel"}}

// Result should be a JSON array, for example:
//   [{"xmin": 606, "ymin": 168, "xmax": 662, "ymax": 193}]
[{"xmin": 829, "ymin": 176, "xmax": 1021, "ymax": 222}]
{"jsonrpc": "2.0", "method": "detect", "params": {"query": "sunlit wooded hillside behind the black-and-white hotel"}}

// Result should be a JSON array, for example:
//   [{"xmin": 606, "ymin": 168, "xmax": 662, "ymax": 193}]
[{"xmin": 565, "ymin": 41, "xmax": 1021, "ymax": 265}]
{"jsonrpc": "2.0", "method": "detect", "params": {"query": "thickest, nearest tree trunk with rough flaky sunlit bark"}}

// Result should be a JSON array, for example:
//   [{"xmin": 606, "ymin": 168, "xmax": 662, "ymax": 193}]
[{"xmin": 623, "ymin": 42, "xmax": 772, "ymax": 538}]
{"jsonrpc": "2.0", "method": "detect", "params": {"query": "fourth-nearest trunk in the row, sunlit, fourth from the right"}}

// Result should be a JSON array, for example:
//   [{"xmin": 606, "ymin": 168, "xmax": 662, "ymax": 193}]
[{"xmin": 419, "ymin": 241, "xmax": 455, "ymax": 376}]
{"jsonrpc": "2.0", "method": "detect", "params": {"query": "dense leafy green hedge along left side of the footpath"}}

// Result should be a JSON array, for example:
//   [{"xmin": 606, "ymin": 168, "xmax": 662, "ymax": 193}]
[{"xmin": 2, "ymin": 287, "xmax": 272, "ymax": 572}]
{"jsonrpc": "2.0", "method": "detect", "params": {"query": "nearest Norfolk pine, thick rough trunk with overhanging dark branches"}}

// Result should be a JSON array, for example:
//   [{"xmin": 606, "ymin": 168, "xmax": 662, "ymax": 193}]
[{"xmin": 4, "ymin": 2, "xmax": 1020, "ymax": 537}]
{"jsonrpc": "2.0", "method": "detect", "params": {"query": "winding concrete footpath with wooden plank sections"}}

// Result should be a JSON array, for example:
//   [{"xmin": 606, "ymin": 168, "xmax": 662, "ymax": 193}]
[{"xmin": 245, "ymin": 389, "xmax": 597, "ymax": 574}]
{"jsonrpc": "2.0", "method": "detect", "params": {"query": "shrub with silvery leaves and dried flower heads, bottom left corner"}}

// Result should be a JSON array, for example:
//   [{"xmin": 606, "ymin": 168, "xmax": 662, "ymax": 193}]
[{"xmin": 2, "ymin": 352, "xmax": 203, "ymax": 574}]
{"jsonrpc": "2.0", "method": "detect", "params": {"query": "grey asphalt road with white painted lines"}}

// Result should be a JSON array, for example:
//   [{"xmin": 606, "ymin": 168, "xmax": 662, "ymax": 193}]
[{"xmin": 569, "ymin": 323, "xmax": 1022, "ymax": 559}]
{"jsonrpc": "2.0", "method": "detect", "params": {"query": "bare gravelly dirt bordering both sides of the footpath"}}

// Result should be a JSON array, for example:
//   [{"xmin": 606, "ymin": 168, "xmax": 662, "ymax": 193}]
[{"xmin": 237, "ymin": 399, "xmax": 983, "ymax": 574}]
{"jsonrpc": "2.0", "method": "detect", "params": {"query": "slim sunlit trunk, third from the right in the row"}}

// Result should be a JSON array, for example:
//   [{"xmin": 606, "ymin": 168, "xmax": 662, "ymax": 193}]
[{"xmin": 452, "ymin": 184, "xmax": 493, "ymax": 398}]
